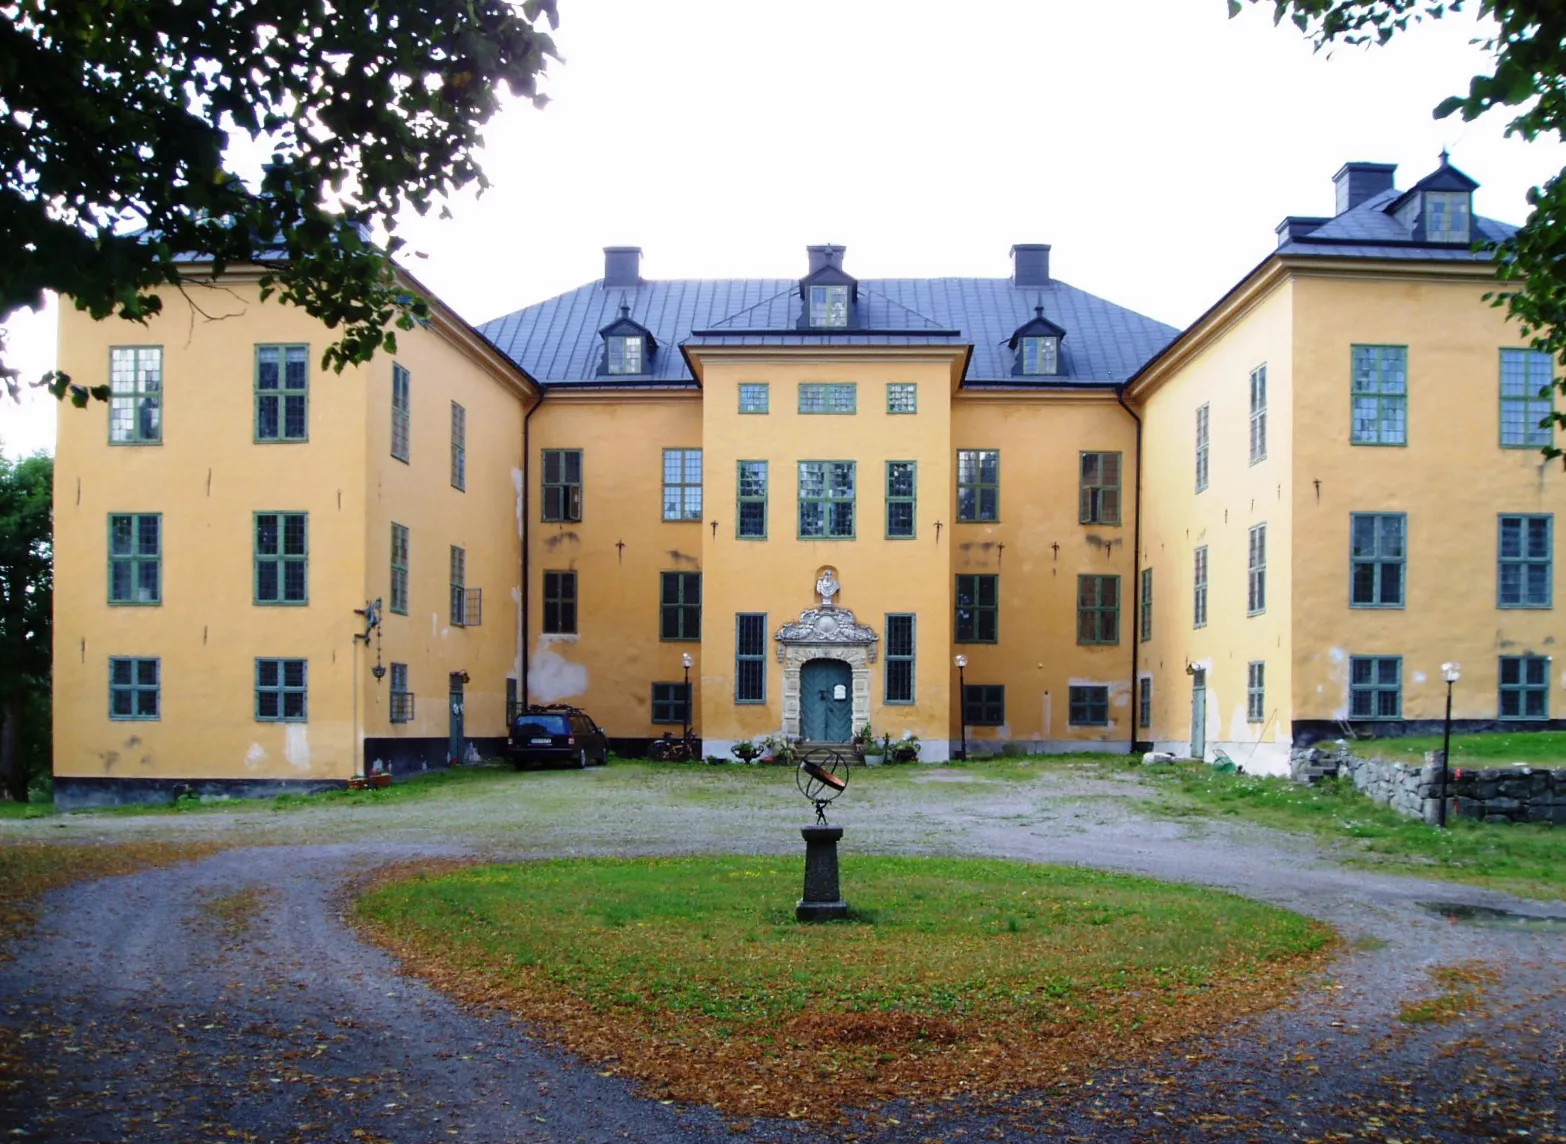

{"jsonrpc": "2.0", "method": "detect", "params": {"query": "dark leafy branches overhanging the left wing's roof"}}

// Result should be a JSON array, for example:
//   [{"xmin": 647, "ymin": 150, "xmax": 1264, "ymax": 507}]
[{"xmin": 0, "ymin": 0, "xmax": 556, "ymax": 404}]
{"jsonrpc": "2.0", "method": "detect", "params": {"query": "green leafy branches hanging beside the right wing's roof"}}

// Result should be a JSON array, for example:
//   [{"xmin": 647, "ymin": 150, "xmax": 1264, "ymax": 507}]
[{"xmin": 1229, "ymin": 0, "xmax": 1566, "ymax": 457}]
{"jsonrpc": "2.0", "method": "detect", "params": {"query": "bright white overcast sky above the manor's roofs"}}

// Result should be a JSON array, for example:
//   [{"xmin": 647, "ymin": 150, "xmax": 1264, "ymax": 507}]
[{"xmin": 0, "ymin": 0, "xmax": 1566, "ymax": 455}]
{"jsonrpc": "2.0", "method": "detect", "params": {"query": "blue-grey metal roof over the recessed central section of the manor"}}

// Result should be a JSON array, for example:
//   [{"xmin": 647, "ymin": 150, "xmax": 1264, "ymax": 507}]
[{"xmin": 479, "ymin": 279, "xmax": 1178, "ymax": 387}]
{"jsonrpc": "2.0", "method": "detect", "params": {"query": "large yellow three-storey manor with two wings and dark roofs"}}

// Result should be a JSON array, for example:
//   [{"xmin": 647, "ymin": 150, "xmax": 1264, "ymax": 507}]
[{"xmin": 55, "ymin": 155, "xmax": 1566, "ymax": 806}]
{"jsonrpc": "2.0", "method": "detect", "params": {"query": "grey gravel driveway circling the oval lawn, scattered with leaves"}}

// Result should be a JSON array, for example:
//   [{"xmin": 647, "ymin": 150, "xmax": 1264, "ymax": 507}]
[{"xmin": 0, "ymin": 767, "xmax": 1566, "ymax": 1144}]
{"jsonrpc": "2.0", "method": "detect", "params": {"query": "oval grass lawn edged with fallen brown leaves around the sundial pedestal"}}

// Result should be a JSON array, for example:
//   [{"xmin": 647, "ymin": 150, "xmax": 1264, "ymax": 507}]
[{"xmin": 357, "ymin": 854, "xmax": 1333, "ymax": 1117}]
